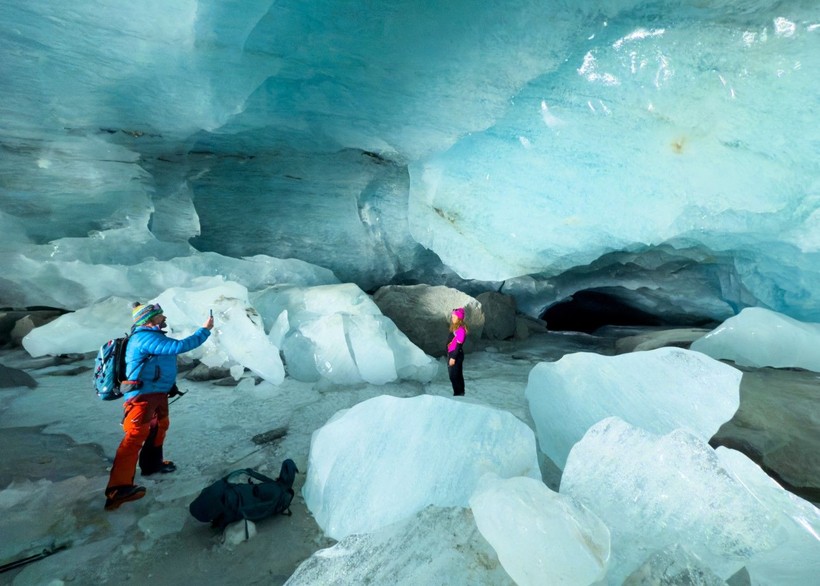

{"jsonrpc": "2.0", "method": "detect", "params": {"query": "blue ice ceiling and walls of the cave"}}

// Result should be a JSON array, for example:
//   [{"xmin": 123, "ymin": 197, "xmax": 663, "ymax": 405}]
[{"xmin": 0, "ymin": 0, "xmax": 820, "ymax": 322}]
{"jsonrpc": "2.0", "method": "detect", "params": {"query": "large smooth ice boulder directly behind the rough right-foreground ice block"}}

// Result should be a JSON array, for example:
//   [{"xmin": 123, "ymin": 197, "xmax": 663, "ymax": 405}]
[{"xmin": 525, "ymin": 348, "xmax": 742, "ymax": 468}]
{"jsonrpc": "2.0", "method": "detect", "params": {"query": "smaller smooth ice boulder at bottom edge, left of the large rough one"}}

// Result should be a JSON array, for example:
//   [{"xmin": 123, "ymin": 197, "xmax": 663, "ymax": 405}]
[{"xmin": 470, "ymin": 474, "xmax": 609, "ymax": 586}]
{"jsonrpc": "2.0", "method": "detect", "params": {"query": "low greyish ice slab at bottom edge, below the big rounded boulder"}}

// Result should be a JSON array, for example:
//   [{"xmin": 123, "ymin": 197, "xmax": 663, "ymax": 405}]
[{"xmin": 285, "ymin": 507, "xmax": 515, "ymax": 586}]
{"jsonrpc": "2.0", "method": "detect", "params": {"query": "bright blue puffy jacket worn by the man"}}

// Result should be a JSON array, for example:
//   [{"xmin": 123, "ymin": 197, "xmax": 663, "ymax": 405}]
[{"xmin": 122, "ymin": 326, "xmax": 211, "ymax": 401}]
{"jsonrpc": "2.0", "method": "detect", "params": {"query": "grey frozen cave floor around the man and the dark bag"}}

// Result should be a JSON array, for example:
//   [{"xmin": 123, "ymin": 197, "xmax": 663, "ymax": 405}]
[{"xmin": 0, "ymin": 331, "xmax": 818, "ymax": 585}]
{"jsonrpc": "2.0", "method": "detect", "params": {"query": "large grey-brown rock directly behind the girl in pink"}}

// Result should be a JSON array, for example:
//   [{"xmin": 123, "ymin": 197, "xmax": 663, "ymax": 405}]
[{"xmin": 373, "ymin": 285, "xmax": 484, "ymax": 357}]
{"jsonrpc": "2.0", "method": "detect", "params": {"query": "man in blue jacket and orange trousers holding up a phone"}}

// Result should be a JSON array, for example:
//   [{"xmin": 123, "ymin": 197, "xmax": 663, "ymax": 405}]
[{"xmin": 105, "ymin": 303, "xmax": 214, "ymax": 511}]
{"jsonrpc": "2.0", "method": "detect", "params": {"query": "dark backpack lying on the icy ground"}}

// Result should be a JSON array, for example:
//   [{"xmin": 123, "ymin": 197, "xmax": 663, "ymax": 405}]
[{"xmin": 188, "ymin": 458, "xmax": 299, "ymax": 530}]
